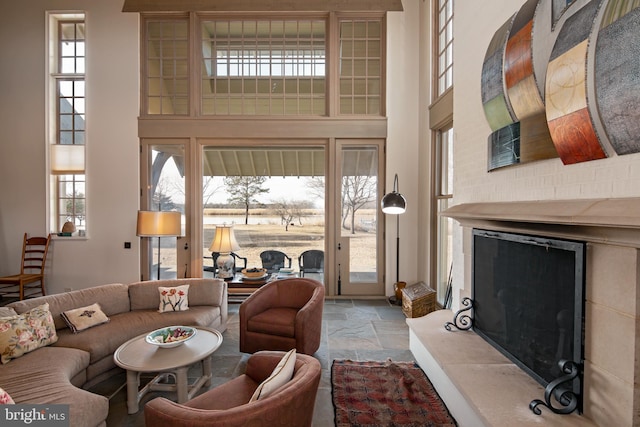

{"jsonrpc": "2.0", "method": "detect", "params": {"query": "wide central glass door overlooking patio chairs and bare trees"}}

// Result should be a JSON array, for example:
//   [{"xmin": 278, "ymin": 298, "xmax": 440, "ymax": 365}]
[{"xmin": 201, "ymin": 144, "xmax": 326, "ymax": 283}]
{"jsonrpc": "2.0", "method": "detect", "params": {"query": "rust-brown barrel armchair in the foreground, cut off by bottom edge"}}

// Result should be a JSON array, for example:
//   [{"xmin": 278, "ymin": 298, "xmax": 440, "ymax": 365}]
[{"xmin": 144, "ymin": 351, "xmax": 321, "ymax": 427}]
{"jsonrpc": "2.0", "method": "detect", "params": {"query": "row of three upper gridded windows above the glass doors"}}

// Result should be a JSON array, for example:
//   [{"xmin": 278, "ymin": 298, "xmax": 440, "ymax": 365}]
[{"xmin": 143, "ymin": 13, "xmax": 384, "ymax": 117}]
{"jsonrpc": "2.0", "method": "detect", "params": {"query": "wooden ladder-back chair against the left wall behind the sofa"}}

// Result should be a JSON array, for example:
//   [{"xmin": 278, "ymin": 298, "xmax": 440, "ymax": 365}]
[{"xmin": 0, "ymin": 233, "xmax": 51, "ymax": 300}]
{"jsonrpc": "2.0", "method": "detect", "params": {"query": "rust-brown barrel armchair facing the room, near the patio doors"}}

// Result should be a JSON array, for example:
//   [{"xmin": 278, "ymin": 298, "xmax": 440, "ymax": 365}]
[{"xmin": 240, "ymin": 278, "xmax": 324, "ymax": 354}]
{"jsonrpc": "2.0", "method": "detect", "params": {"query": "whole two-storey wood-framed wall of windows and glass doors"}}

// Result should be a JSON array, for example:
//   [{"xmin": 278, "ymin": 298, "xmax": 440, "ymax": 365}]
[{"xmin": 139, "ymin": 10, "xmax": 387, "ymax": 295}]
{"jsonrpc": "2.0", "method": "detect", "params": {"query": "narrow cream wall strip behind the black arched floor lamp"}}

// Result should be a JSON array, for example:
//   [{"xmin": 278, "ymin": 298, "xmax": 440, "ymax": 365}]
[{"xmin": 385, "ymin": 0, "xmax": 428, "ymax": 295}]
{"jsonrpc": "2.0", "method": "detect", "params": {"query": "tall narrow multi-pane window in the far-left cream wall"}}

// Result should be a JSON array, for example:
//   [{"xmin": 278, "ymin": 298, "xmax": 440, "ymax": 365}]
[{"xmin": 49, "ymin": 14, "xmax": 86, "ymax": 234}]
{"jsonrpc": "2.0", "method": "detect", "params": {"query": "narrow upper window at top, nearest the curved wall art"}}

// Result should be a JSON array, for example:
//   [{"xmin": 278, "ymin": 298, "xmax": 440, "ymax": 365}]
[{"xmin": 435, "ymin": 0, "xmax": 453, "ymax": 96}]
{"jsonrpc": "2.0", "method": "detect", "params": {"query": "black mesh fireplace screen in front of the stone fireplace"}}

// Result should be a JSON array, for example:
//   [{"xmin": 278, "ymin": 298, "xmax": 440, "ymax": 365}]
[{"xmin": 473, "ymin": 230, "xmax": 585, "ymax": 393}]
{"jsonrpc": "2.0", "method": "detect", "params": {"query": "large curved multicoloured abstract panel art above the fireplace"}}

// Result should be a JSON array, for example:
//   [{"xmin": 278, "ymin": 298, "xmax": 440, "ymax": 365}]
[{"xmin": 481, "ymin": 0, "xmax": 640, "ymax": 170}]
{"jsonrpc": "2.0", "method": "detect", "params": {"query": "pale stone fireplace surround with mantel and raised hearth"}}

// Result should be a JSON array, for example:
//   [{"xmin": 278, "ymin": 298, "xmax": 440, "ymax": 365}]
[{"xmin": 407, "ymin": 198, "xmax": 640, "ymax": 427}]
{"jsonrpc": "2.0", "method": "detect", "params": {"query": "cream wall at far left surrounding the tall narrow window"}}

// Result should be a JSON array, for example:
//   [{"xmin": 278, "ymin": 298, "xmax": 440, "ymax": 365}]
[{"xmin": 0, "ymin": 0, "xmax": 140, "ymax": 293}]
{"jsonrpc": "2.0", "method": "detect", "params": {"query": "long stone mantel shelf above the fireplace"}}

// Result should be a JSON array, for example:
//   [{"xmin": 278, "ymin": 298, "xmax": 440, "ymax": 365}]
[{"xmin": 443, "ymin": 198, "xmax": 640, "ymax": 247}]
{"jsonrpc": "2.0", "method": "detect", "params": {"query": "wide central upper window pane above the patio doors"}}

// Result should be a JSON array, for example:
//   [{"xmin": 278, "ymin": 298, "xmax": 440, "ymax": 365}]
[{"xmin": 201, "ymin": 20, "xmax": 326, "ymax": 115}]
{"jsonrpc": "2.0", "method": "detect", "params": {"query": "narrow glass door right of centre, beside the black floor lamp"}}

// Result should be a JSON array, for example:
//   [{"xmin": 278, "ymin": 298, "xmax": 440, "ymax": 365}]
[{"xmin": 335, "ymin": 140, "xmax": 384, "ymax": 296}]
